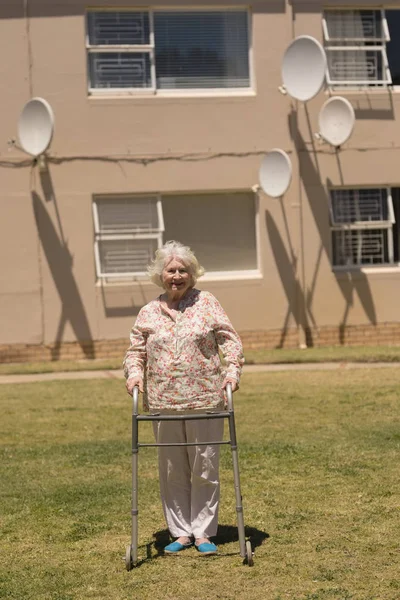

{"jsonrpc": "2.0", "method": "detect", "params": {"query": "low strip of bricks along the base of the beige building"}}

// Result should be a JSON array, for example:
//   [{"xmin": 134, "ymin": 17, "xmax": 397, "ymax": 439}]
[{"xmin": 0, "ymin": 323, "xmax": 400, "ymax": 363}]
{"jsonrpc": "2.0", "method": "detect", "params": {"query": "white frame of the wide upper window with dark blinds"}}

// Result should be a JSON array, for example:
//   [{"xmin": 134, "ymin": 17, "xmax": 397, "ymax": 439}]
[{"xmin": 85, "ymin": 5, "xmax": 255, "ymax": 98}]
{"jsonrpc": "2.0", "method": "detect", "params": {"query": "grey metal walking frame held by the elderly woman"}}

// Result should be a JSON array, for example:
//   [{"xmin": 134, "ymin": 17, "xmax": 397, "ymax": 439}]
[{"xmin": 125, "ymin": 383, "xmax": 253, "ymax": 571}]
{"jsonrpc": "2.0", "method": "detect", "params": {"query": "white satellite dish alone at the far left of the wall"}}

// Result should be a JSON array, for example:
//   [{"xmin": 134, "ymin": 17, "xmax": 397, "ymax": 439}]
[{"xmin": 18, "ymin": 98, "xmax": 54, "ymax": 156}]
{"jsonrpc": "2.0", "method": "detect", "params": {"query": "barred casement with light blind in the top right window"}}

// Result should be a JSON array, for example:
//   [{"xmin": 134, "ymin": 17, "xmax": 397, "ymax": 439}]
[{"xmin": 322, "ymin": 9, "xmax": 392, "ymax": 87}]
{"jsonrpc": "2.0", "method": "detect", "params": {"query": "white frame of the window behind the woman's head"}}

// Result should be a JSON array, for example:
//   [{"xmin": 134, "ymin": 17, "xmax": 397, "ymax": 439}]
[{"xmin": 92, "ymin": 189, "xmax": 262, "ymax": 285}]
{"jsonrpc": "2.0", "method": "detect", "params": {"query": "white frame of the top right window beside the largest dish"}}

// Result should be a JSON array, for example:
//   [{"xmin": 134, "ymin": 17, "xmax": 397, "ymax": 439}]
[{"xmin": 322, "ymin": 5, "xmax": 393, "ymax": 90}]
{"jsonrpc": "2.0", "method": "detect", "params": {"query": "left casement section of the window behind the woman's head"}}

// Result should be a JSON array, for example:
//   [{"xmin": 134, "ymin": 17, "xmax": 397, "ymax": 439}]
[{"xmin": 93, "ymin": 196, "xmax": 164, "ymax": 278}]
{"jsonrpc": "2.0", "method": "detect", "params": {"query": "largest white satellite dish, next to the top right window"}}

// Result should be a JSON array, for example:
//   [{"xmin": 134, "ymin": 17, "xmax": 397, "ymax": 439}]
[{"xmin": 282, "ymin": 35, "xmax": 327, "ymax": 102}]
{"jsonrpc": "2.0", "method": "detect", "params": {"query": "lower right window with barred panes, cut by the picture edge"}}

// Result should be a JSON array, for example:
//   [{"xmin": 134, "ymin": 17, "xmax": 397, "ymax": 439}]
[{"xmin": 330, "ymin": 188, "xmax": 400, "ymax": 267}]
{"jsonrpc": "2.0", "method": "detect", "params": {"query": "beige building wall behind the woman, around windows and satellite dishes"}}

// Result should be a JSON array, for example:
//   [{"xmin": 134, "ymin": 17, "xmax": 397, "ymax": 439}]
[{"xmin": 0, "ymin": 0, "xmax": 400, "ymax": 358}]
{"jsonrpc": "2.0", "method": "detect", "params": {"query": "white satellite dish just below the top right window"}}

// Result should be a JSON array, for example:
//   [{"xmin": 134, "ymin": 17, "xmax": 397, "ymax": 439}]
[{"xmin": 319, "ymin": 96, "xmax": 356, "ymax": 146}]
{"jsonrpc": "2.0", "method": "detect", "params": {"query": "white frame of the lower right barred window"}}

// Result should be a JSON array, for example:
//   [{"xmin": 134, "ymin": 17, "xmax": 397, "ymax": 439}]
[{"xmin": 328, "ymin": 186, "xmax": 400, "ymax": 272}]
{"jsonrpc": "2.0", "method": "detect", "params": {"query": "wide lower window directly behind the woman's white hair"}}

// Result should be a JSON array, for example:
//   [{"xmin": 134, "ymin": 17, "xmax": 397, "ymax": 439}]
[{"xmin": 93, "ymin": 192, "xmax": 259, "ymax": 279}]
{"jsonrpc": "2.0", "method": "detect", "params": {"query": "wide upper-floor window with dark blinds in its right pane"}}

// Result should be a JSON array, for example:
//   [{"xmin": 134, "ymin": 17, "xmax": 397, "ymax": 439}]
[{"xmin": 87, "ymin": 9, "xmax": 250, "ymax": 93}]
